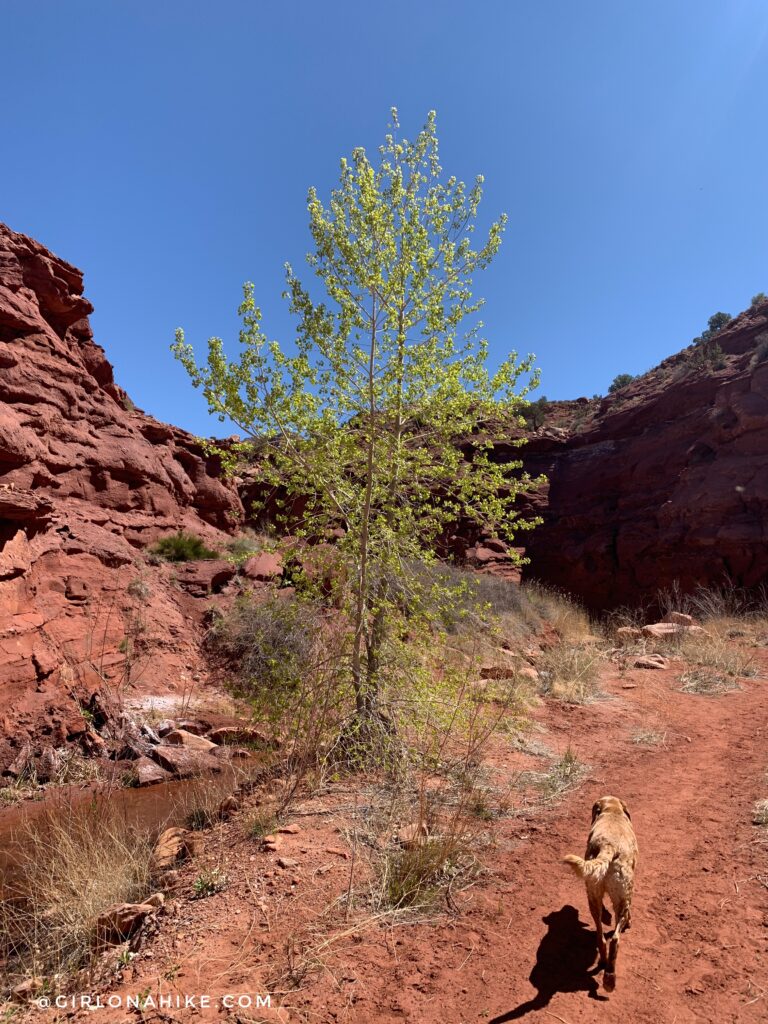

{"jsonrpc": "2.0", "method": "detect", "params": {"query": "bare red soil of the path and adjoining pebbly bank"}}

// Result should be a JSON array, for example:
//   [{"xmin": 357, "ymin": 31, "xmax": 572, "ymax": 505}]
[{"xmin": 24, "ymin": 651, "xmax": 768, "ymax": 1024}]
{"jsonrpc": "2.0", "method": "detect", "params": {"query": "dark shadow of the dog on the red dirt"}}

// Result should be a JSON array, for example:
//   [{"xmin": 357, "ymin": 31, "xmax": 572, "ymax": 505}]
[{"xmin": 490, "ymin": 904, "xmax": 605, "ymax": 1024}]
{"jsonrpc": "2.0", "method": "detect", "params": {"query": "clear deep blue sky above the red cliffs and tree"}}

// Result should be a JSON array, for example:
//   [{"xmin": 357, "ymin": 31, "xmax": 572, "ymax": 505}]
[{"xmin": 0, "ymin": 0, "xmax": 768, "ymax": 433}]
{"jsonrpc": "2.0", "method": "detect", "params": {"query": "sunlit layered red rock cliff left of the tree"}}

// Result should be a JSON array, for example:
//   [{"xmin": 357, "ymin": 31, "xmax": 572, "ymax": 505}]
[{"xmin": 0, "ymin": 225, "xmax": 242, "ymax": 769}]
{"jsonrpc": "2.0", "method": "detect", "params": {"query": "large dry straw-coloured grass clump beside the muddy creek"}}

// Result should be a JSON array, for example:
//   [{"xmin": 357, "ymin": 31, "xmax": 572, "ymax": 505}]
[{"xmin": 0, "ymin": 801, "xmax": 153, "ymax": 985}]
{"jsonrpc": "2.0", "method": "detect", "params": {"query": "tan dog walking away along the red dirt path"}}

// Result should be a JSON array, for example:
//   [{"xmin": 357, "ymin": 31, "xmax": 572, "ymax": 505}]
[{"xmin": 563, "ymin": 797, "xmax": 637, "ymax": 992}]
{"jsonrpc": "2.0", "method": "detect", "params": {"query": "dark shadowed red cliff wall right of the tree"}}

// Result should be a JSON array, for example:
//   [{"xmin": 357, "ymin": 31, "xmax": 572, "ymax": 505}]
[{"xmin": 518, "ymin": 303, "xmax": 768, "ymax": 609}]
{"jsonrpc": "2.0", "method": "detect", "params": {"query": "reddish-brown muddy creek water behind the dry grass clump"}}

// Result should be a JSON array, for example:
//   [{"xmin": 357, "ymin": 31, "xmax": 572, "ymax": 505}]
[{"xmin": 0, "ymin": 757, "xmax": 262, "ymax": 895}]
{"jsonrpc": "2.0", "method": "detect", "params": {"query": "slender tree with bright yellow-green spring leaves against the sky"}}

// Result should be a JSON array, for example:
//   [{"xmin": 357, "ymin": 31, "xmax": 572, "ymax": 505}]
[{"xmin": 173, "ymin": 110, "xmax": 539, "ymax": 730}]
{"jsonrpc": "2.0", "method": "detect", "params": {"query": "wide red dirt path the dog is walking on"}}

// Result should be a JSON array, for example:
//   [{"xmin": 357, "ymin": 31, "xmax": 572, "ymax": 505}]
[{"xmin": 301, "ymin": 659, "xmax": 768, "ymax": 1024}]
